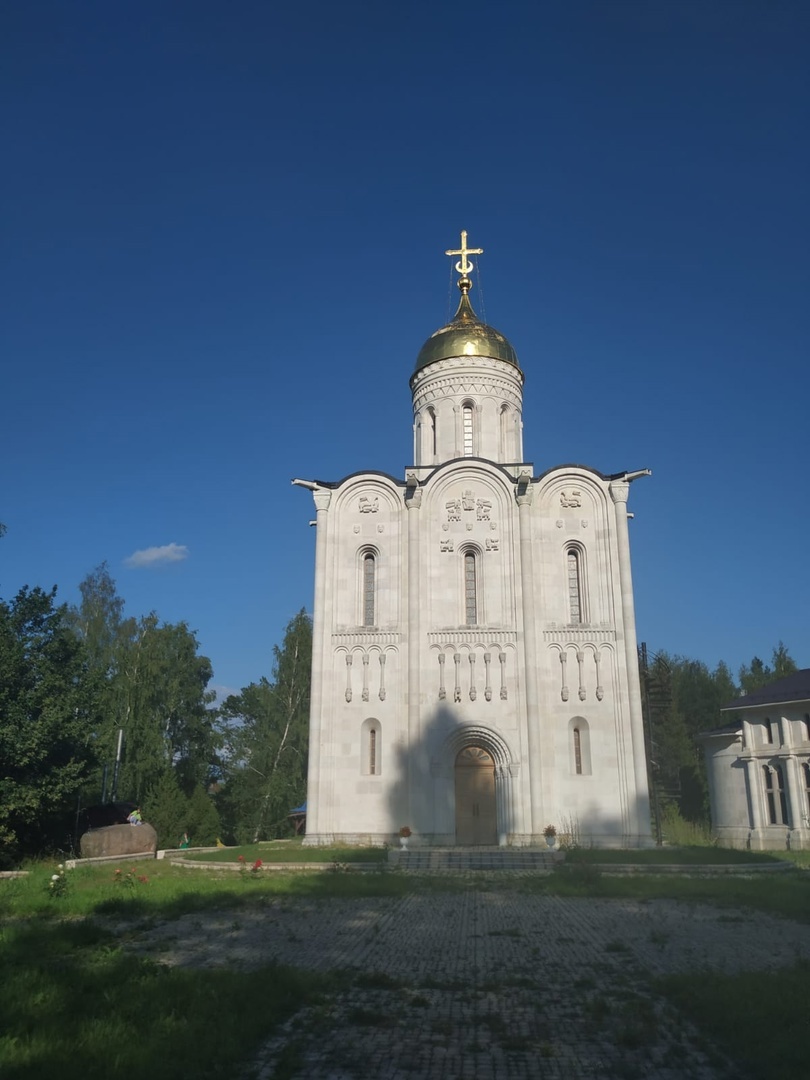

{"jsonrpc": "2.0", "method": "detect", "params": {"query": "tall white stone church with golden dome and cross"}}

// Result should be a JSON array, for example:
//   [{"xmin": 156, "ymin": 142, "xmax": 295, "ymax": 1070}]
[{"xmin": 294, "ymin": 233, "xmax": 652, "ymax": 847}]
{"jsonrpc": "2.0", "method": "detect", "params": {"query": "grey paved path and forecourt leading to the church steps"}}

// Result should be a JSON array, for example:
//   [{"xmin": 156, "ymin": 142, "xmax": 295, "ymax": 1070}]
[{"xmin": 120, "ymin": 882, "xmax": 810, "ymax": 1080}]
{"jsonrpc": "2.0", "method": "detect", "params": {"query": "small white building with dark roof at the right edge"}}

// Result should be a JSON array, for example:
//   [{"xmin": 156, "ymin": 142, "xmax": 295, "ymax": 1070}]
[{"xmin": 699, "ymin": 669, "xmax": 810, "ymax": 851}]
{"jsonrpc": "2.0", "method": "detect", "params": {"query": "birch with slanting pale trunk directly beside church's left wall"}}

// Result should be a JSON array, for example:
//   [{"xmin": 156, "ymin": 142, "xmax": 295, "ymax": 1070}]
[{"xmin": 220, "ymin": 611, "xmax": 312, "ymax": 842}]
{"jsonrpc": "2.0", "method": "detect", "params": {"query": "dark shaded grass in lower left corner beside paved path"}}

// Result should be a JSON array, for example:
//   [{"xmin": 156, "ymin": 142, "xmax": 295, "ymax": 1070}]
[{"xmin": 0, "ymin": 920, "xmax": 337, "ymax": 1080}]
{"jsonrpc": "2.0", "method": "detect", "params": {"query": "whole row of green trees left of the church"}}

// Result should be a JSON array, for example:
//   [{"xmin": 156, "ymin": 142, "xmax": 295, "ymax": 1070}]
[{"xmin": 0, "ymin": 563, "xmax": 312, "ymax": 864}]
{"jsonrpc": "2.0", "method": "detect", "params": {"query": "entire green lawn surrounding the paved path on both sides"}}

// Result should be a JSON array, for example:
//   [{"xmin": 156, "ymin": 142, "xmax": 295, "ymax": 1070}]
[{"xmin": 0, "ymin": 846, "xmax": 810, "ymax": 1080}]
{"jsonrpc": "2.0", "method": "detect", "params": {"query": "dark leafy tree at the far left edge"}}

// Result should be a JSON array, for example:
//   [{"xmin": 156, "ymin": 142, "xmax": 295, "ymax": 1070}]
[{"xmin": 0, "ymin": 588, "xmax": 98, "ymax": 853}]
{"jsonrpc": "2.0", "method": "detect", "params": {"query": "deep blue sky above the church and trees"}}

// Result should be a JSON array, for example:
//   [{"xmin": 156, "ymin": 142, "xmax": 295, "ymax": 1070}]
[{"xmin": 0, "ymin": 0, "xmax": 810, "ymax": 689}]
